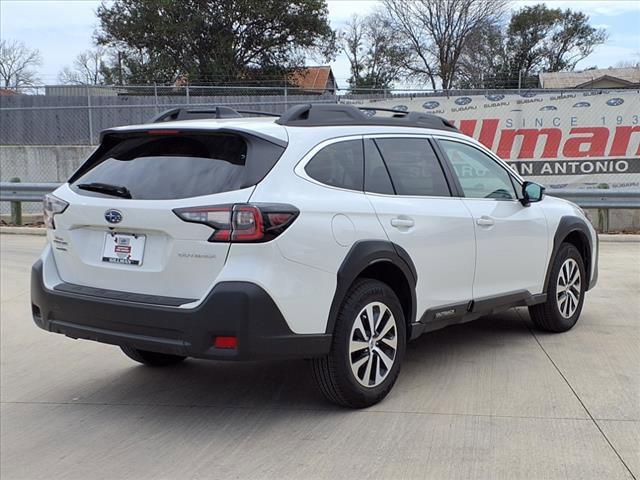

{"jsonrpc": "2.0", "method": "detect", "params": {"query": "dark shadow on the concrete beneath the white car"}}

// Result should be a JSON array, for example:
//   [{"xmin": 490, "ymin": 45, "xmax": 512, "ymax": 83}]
[{"xmin": 58, "ymin": 310, "xmax": 531, "ymax": 411}]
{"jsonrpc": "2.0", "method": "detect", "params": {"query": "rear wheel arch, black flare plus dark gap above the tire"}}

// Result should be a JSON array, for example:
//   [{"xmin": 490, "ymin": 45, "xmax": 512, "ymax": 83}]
[{"xmin": 326, "ymin": 240, "xmax": 418, "ymax": 334}]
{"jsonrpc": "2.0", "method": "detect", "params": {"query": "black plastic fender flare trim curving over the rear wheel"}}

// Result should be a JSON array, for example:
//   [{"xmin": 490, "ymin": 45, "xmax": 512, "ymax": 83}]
[{"xmin": 325, "ymin": 240, "xmax": 418, "ymax": 334}]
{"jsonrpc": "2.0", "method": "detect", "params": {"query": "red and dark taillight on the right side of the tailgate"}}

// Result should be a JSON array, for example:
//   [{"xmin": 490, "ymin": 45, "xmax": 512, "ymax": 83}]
[{"xmin": 173, "ymin": 203, "xmax": 299, "ymax": 242}]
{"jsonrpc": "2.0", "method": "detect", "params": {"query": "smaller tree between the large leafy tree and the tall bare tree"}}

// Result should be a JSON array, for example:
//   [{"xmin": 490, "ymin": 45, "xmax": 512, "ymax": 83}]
[{"xmin": 340, "ymin": 12, "xmax": 407, "ymax": 91}]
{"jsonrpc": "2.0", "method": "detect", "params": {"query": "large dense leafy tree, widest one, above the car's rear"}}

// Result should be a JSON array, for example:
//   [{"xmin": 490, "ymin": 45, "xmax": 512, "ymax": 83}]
[{"xmin": 96, "ymin": 0, "xmax": 335, "ymax": 83}]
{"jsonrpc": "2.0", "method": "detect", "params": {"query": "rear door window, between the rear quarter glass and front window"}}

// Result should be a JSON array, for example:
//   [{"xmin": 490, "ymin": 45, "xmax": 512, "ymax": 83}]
[{"xmin": 376, "ymin": 138, "xmax": 450, "ymax": 197}]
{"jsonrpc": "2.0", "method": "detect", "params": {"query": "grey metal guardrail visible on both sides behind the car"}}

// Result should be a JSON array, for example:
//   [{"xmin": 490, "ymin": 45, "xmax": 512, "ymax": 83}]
[{"xmin": 0, "ymin": 182, "xmax": 640, "ymax": 208}]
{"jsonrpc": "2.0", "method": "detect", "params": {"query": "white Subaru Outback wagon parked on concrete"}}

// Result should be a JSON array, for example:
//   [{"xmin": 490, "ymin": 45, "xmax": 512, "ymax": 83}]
[{"xmin": 31, "ymin": 105, "xmax": 597, "ymax": 407}]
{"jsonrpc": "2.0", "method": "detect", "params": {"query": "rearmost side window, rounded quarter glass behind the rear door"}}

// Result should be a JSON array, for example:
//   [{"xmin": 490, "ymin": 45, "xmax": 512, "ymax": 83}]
[{"xmin": 304, "ymin": 140, "xmax": 364, "ymax": 191}]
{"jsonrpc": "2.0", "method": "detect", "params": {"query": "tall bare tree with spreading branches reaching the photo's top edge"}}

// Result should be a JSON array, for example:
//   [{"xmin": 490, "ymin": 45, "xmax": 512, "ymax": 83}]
[{"xmin": 383, "ymin": 0, "xmax": 509, "ymax": 90}]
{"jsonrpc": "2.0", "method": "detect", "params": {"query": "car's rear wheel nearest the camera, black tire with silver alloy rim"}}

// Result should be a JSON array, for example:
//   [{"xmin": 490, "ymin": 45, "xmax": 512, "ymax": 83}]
[{"xmin": 312, "ymin": 279, "xmax": 407, "ymax": 408}]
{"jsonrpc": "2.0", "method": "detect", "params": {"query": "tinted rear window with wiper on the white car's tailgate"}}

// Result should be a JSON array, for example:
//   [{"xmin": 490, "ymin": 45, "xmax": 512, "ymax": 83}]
[{"xmin": 70, "ymin": 133, "xmax": 284, "ymax": 200}]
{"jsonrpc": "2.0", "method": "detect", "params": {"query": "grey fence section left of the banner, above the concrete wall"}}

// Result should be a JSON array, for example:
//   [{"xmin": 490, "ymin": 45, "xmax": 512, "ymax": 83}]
[{"xmin": 0, "ymin": 85, "xmax": 336, "ymax": 145}]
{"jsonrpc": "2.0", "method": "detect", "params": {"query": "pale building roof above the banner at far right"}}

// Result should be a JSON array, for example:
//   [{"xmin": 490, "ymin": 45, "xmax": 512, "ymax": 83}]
[{"xmin": 539, "ymin": 67, "xmax": 640, "ymax": 88}]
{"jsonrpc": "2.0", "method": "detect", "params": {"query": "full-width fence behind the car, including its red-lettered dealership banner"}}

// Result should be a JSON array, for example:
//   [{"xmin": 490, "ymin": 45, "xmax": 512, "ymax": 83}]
[{"xmin": 0, "ymin": 85, "xmax": 640, "ymax": 216}]
